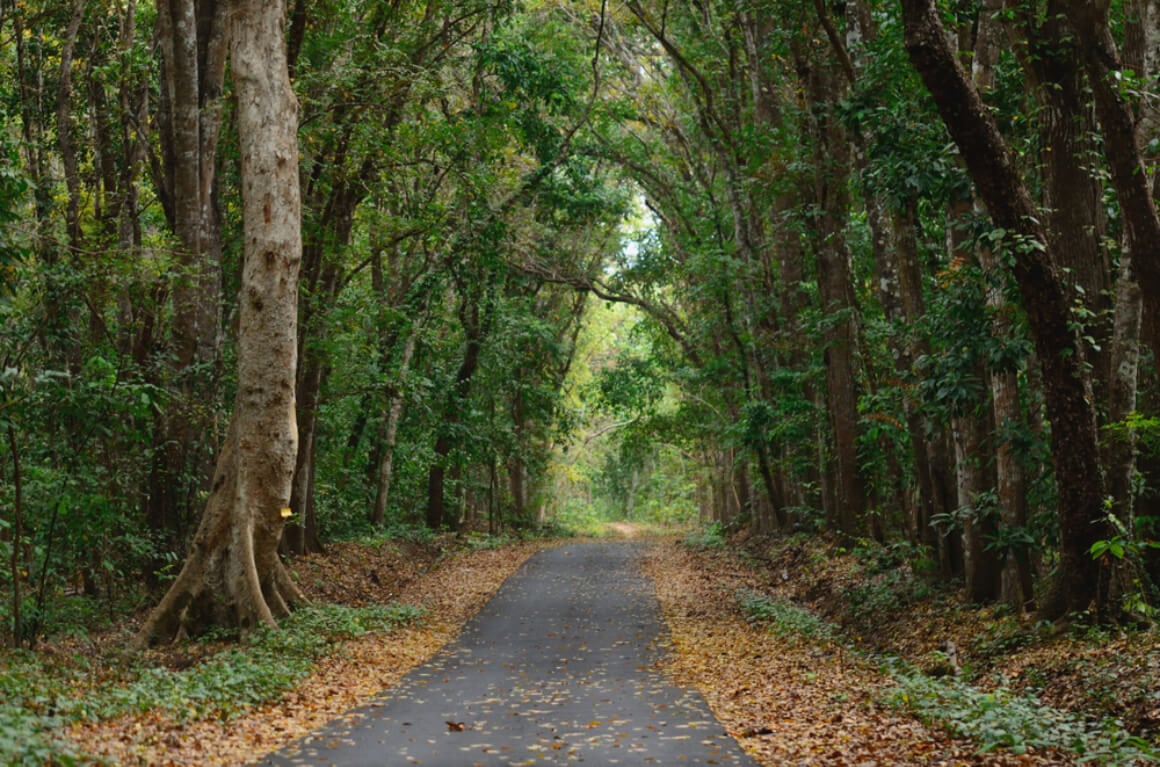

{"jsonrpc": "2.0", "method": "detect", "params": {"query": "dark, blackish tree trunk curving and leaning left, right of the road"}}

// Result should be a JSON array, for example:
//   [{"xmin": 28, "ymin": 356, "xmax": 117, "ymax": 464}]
[{"xmin": 902, "ymin": 0, "xmax": 1108, "ymax": 620}]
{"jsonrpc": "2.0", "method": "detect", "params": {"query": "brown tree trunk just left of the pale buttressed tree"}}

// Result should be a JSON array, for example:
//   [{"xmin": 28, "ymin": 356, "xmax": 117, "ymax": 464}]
[{"xmin": 147, "ymin": 0, "xmax": 229, "ymax": 550}]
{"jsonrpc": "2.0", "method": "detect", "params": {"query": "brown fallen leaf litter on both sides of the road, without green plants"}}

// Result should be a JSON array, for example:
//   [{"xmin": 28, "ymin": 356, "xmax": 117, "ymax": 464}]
[{"xmin": 42, "ymin": 530, "xmax": 1160, "ymax": 767}]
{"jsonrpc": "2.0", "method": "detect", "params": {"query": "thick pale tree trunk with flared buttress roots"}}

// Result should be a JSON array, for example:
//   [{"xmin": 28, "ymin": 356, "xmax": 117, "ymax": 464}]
[{"xmin": 137, "ymin": 0, "xmax": 303, "ymax": 643}]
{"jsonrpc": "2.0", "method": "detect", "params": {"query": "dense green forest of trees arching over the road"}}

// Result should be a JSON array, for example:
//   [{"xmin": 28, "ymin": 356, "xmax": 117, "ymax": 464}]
[{"xmin": 0, "ymin": 0, "xmax": 1160, "ymax": 714}]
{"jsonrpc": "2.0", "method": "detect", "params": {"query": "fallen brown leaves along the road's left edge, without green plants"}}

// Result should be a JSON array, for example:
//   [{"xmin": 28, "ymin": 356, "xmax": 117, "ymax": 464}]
[{"xmin": 58, "ymin": 531, "xmax": 553, "ymax": 766}]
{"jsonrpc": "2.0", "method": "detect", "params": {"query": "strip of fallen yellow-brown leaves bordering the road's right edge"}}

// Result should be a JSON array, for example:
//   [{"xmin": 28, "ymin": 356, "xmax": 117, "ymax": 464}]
[{"xmin": 645, "ymin": 541, "xmax": 1068, "ymax": 767}]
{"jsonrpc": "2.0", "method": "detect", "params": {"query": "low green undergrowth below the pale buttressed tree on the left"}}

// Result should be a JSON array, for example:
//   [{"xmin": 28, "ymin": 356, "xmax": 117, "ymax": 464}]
[{"xmin": 0, "ymin": 603, "xmax": 422, "ymax": 765}]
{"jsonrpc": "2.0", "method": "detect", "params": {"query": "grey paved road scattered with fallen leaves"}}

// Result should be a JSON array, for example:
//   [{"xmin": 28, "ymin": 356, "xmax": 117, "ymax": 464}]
[{"xmin": 260, "ymin": 542, "xmax": 755, "ymax": 767}]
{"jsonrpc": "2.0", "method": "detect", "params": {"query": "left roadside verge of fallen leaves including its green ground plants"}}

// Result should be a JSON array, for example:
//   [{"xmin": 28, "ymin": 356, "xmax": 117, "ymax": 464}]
[{"xmin": 0, "ymin": 531, "xmax": 549, "ymax": 765}]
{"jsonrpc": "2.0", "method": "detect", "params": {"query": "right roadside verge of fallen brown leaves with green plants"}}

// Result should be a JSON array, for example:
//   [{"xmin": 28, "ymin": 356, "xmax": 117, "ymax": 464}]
[{"xmin": 648, "ymin": 535, "xmax": 1160, "ymax": 765}]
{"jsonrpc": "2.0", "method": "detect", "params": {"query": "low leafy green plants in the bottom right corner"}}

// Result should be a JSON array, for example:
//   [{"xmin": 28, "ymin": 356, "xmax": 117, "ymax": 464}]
[{"xmin": 887, "ymin": 668, "xmax": 1160, "ymax": 765}]
